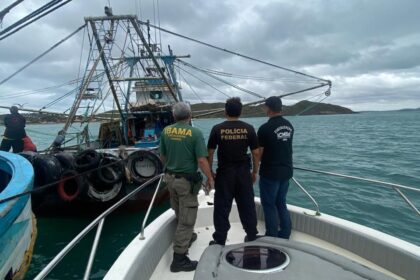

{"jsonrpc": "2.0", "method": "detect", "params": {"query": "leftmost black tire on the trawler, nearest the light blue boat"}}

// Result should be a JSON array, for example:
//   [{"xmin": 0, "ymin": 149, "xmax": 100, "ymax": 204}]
[{"xmin": 32, "ymin": 155, "xmax": 61, "ymax": 193}]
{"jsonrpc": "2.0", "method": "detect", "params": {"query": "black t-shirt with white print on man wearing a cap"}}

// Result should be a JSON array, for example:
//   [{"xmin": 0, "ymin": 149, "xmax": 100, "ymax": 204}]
[{"xmin": 258, "ymin": 116, "xmax": 294, "ymax": 180}]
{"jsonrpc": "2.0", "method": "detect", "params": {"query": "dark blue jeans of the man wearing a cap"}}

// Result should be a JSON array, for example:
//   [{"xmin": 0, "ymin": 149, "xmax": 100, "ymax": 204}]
[{"xmin": 260, "ymin": 177, "xmax": 292, "ymax": 239}]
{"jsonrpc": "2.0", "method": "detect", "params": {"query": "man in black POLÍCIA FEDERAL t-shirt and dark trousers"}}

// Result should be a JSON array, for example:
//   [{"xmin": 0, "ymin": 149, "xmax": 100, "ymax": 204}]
[{"xmin": 207, "ymin": 98, "xmax": 259, "ymax": 245}]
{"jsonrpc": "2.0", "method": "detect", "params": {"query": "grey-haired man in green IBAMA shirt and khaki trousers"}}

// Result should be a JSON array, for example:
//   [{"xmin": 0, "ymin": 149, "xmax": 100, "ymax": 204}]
[{"xmin": 160, "ymin": 102, "xmax": 214, "ymax": 272}]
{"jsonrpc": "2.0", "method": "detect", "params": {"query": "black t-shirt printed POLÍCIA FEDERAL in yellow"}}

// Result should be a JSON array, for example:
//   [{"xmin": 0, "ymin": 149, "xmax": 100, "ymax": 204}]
[{"xmin": 207, "ymin": 121, "xmax": 258, "ymax": 168}]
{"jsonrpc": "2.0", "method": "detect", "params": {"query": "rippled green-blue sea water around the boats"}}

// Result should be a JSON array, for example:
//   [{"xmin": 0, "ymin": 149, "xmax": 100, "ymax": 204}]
[{"xmin": 0, "ymin": 111, "xmax": 420, "ymax": 279}]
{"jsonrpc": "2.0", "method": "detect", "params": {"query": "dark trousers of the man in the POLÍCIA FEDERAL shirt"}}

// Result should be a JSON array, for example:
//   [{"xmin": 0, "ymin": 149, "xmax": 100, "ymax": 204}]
[{"xmin": 213, "ymin": 164, "xmax": 258, "ymax": 245}]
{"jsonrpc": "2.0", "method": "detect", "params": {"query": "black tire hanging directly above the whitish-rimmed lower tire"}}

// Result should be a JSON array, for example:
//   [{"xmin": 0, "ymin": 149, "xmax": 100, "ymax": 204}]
[{"xmin": 94, "ymin": 154, "xmax": 124, "ymax": 185}]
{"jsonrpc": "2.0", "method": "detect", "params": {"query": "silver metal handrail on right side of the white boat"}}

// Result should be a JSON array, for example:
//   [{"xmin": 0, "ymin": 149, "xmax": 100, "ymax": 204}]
[{"xmin": 294, "ymin": 167, "xmax": 420, "ymax": 216}]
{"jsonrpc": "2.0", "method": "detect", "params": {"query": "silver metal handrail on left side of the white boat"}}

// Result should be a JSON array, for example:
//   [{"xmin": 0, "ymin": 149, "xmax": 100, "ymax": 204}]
[{"xmin": 34, "ymin": 174, "xmax": 163, "ymax": 280}]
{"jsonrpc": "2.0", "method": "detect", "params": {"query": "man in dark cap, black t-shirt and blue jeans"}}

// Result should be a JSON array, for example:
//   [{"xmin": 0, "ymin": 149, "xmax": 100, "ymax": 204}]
[{"xmin": 258, "ymin": 96, "xmax": 294, "ymax": 239}]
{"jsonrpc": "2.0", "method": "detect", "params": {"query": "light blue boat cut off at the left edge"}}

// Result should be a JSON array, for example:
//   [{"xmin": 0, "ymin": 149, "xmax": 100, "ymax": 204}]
[{"xmin": 0, "ymin": 151, "xmax": 36, "ymax": 279}]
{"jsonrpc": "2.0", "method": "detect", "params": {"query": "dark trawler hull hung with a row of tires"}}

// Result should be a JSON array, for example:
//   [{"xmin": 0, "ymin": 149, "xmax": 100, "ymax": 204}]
[{"xmin": 23, "ymin": 148, "xmax": 169, "ymax": 216}]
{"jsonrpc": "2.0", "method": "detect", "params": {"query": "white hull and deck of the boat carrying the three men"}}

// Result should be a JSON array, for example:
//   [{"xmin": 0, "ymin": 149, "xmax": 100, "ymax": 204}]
[{"xmin": 105, "ymin": 192, "xmax": 420, "ymax": 280}]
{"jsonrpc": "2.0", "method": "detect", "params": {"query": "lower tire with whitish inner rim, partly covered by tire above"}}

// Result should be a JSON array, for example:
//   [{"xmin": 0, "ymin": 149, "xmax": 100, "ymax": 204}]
[{"xmin": 87, "ymin": 168, "xmax": 122, "ymax": 202}]
